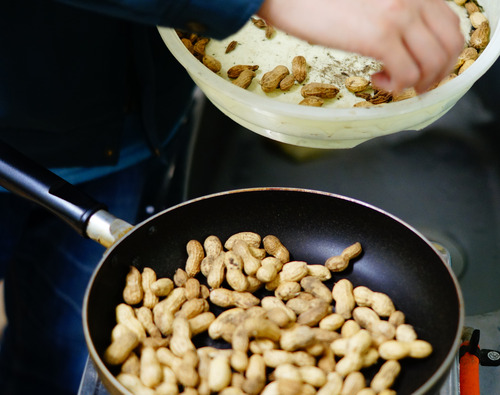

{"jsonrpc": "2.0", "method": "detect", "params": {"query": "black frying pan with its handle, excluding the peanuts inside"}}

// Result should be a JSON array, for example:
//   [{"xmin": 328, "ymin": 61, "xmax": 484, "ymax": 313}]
[{"xmin": 0, "ymin": 144, "xmax": 464, "ymax": 394}]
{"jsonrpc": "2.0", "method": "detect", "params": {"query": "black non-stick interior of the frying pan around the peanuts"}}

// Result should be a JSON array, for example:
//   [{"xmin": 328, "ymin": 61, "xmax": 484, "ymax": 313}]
[{"xmin": 85, "ymin": 188, "xmax": 463, "ymax": 394}]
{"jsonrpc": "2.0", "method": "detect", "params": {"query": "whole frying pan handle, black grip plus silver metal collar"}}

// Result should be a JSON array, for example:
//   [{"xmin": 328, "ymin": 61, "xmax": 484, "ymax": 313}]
[{"xmin": 0, "ymin": 141, "xmax": 131, "ymax": 247}]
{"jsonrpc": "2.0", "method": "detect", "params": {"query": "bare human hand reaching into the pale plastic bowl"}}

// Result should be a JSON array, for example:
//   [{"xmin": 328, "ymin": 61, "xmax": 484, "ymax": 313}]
[{"xmin": 258, "ymin": 0, "xmax": 464, "ymax": 93}]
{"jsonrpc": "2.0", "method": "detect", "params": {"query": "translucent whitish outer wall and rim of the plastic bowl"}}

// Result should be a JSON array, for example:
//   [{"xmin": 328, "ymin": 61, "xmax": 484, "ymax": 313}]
[{"xmin": 159, "ymin": 0, "xmax": 500, "ymax": 148}]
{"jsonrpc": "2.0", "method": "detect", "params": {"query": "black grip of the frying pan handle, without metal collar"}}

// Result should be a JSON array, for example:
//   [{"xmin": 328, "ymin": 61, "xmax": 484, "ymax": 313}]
[{"xmin": 0, "ymin": 141, "xmax": 106, "ymax": 237}]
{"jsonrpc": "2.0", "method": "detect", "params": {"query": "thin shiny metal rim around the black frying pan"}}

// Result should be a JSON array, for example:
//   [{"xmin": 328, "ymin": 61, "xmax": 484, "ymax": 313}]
[{"xmin": 82, "ymin": 187, "xmax": 465, "ymax": 395}]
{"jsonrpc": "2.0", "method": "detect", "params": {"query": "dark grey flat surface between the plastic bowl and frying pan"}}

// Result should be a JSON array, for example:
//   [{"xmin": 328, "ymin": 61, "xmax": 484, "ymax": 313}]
[{"xmin": 189, "ymin": 61, "xmax": 500, "ymax": 315}]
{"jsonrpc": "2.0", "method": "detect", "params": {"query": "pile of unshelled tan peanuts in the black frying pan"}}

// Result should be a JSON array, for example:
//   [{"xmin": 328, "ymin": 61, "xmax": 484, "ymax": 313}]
[{"xmin": 104, "ymin": 232, "xmax": 432, "ymax": 395}]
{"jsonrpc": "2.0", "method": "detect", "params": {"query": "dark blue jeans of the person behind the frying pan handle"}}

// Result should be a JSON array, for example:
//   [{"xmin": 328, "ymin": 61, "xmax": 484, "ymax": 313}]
[{"xmin": 0, "ymin": 160, "xmax": 148, "ymax": 395}]
